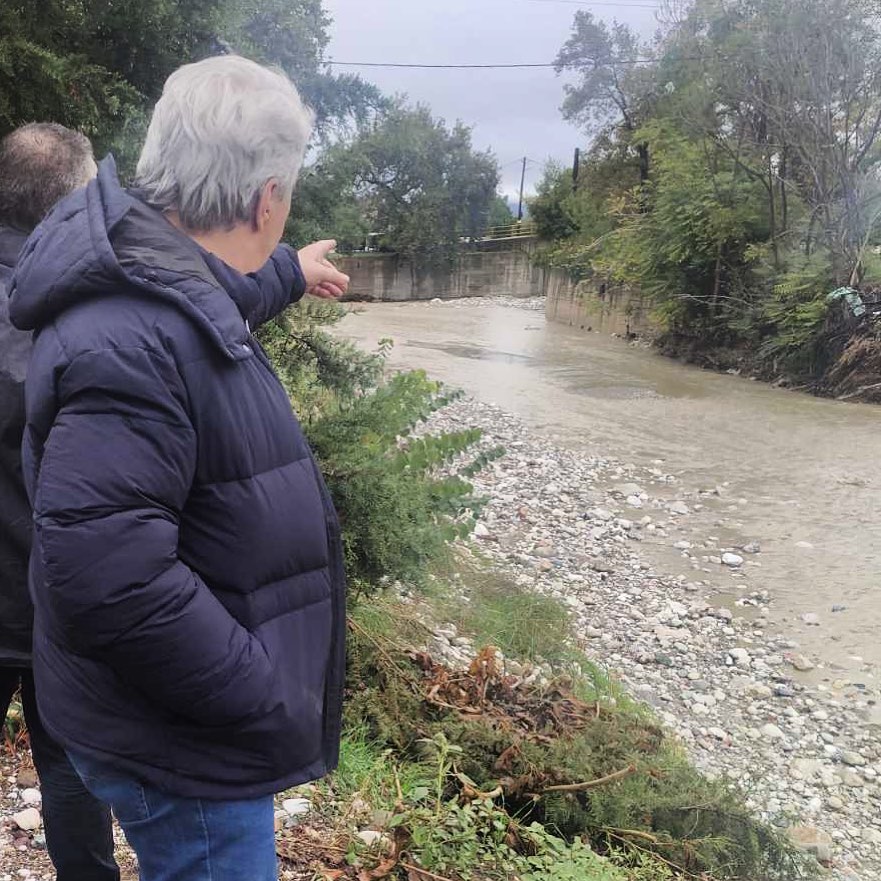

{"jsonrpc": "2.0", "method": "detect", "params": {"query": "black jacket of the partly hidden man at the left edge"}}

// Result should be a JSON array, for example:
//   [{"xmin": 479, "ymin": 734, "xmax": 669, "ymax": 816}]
[{"xmin": 0, "ymin": 226, "xmax": 34, "ymax": 666}]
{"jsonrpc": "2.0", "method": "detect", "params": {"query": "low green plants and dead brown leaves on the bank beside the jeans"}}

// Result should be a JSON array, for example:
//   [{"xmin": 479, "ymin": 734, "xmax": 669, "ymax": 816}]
[{"xmin": 340, "ymin": 592, "xmax": 812, "ymax": 881}]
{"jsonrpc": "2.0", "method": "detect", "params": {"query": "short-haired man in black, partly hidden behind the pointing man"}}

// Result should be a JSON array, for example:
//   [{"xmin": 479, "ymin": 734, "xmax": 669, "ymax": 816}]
[{"xmin": 0, "ymin": 123, "xmax": 119, "ymax": 881}]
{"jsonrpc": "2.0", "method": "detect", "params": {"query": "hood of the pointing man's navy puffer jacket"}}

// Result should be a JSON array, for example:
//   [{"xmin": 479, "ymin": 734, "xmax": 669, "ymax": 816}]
[{"xmin": 9, "ymin": 157, "xmax": 259, "ymax": 360}]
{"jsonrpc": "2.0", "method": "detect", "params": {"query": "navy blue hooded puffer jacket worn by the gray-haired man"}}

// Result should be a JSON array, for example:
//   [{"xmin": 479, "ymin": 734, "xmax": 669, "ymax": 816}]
[{"xmin": 10, "ymin": 160, "xmax": 345, "ymax": 799}]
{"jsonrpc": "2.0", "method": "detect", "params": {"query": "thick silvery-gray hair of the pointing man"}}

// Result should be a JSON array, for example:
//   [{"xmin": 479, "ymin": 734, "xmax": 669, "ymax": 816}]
[{"xmin": 135, "ymin": 55, "xmax": 314, "ymax": 232}]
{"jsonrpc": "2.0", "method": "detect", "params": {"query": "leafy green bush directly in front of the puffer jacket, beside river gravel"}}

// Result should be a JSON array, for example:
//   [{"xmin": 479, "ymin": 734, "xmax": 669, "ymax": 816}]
[{"xmin": 261, "ymin": 302, "xmax": 498, "ymax": 595}]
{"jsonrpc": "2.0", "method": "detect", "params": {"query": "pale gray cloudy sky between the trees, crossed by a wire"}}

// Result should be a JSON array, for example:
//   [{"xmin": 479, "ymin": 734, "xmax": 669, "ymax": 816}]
[{"xmin": 324, "ymin": 0, "xmax": 660, "ymax": 195}]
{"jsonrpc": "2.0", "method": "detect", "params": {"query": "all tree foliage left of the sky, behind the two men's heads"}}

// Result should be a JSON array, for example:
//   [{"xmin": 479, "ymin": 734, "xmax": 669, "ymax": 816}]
[{"xmin": 0, "ymin": 0, "xmax": 505, "ymax": 260}]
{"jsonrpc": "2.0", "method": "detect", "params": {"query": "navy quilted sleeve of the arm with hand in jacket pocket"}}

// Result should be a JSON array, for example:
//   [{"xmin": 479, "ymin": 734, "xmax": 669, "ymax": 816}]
[{"xmin": 34, "ymin": 348, "xmax": 272, "ymax": 725}]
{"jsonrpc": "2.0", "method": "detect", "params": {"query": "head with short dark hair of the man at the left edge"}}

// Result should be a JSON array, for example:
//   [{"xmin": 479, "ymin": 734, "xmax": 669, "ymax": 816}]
[{"xmin": 0, "ymin": 122, "xmax": 94, "ymax": 232}]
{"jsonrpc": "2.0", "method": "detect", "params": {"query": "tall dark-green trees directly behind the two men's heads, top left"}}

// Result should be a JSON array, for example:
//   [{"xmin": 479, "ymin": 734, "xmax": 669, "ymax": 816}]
[{"xmin": 0, "ymin": 0, "xmax": 387, "ymax": 162}]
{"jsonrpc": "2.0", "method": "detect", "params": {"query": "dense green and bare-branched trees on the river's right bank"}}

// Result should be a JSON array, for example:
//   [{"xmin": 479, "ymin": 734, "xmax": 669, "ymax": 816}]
[{"xmin": 531, "ymin": 0, "xmax": 881, "ymax": 374}]
